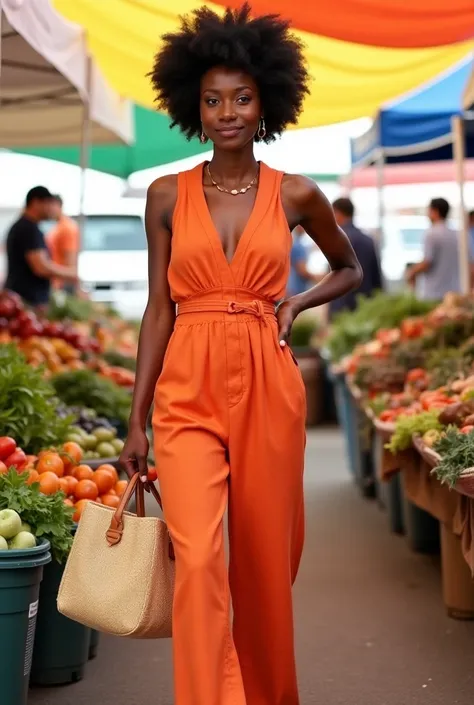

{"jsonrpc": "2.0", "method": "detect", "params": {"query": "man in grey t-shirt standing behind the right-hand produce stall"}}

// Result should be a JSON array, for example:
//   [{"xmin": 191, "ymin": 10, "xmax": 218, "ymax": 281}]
[{"xmin": 407, "ymin": 198, "xmax": 473, "ymax": 301}]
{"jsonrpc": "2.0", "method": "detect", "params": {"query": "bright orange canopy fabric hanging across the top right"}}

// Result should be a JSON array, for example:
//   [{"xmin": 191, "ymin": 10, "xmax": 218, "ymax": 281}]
[{"xmin": 218, "ymin": 0, "xmax": 474, "ymax": 47}]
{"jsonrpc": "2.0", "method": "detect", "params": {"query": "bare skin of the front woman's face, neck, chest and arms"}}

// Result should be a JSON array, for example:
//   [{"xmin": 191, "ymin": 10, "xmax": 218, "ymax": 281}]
[{"xmin": 120, "ymin": 67, "xmax": 362, "ymax": 482}]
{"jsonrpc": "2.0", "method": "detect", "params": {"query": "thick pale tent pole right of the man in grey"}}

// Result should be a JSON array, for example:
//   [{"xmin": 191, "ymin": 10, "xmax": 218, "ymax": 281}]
[{"xmin": 451, "ymin": 115, "xmax": 471, "ymax": 294}]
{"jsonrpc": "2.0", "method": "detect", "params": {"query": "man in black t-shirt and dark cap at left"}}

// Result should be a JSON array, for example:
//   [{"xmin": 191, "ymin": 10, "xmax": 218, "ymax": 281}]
[{"xmin": 5, "ymin": 186, "xmax": 77, "ymax": 307}]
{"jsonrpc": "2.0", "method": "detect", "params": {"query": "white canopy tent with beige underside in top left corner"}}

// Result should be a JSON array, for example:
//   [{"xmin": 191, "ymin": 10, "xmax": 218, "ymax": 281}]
[{"xmin": 0, "ymin": 0, "xmax": 133, "ymax": 147}]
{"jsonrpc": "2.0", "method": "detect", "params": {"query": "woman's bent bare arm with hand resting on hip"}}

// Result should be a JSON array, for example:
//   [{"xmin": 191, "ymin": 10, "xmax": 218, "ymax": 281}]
[{"xmin": 278, "ymin": 176, "xmax": 362, "ymax": 342}]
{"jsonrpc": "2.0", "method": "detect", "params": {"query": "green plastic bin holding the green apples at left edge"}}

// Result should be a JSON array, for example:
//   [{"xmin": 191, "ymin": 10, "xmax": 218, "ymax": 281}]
[{"xmin": 0, "ymin": 539, "xmax": 51, "ymax": 705}]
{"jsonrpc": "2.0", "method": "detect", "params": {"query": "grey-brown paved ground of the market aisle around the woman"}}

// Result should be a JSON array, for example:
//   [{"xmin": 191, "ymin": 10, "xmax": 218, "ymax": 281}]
[{"xmin": 29, "ymin": 430, "xmax": 474, "ymax": 705}]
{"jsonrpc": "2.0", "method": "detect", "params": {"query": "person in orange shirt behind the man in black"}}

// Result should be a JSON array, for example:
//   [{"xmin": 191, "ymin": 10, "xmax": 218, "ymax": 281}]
[{"xmin": 47, "ymin": 196, "xmax": 79, "ymax": 294}]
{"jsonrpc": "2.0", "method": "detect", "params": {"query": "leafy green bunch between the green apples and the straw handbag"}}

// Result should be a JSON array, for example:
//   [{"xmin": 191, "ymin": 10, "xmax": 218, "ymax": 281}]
[{"xmin": 0, "ymin": 468, "xmax": 74, "ymax": 563}]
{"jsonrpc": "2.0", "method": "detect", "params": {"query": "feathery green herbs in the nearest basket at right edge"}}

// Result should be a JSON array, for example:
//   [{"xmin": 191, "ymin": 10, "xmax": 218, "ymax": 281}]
[{"xmin": 433, "ymin": 427, "xmax": 474, "ymax": 488}]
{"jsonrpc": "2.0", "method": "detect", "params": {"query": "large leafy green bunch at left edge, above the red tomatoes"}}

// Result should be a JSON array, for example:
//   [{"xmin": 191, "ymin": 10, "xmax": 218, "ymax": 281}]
[{"xmin": 0, "ymin": 345, "xmax": 72, "ymax": 453}]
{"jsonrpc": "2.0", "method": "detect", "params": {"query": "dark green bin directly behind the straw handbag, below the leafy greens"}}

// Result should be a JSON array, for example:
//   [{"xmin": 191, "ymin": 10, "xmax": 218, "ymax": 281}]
[{"xmin": 29, "ymin": 561, "xmax": 91, "ymax": 680}]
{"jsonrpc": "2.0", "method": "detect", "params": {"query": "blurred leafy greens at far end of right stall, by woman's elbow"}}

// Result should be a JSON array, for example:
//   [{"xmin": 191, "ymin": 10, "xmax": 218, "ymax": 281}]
[{"xmin": 327, "ymin": 292, "xmax": 436, "ymax": 361}]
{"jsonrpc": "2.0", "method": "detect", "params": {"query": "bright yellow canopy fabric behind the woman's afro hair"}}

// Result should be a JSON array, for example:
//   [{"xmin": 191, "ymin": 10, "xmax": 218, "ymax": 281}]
[{"xmin": 53, "ymin": 0, "xmax": 474, "ymax": 126}]
